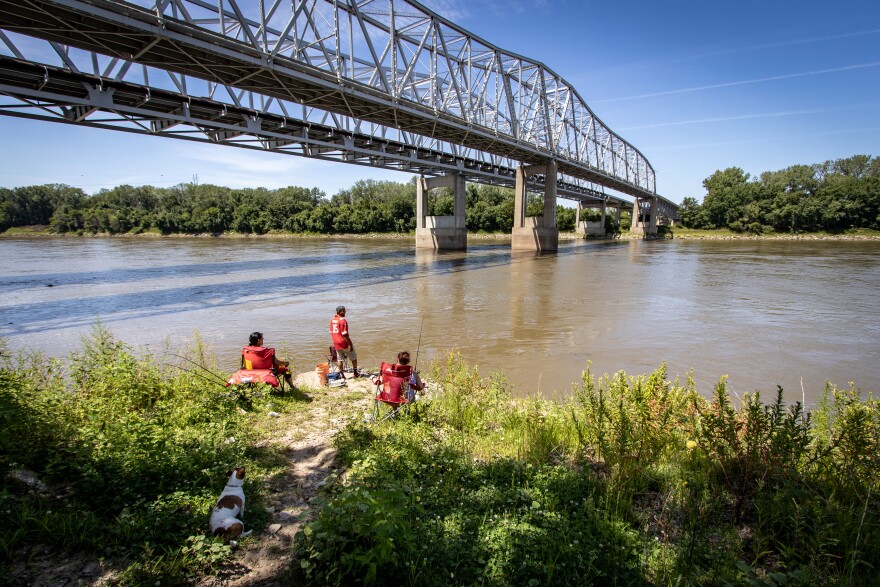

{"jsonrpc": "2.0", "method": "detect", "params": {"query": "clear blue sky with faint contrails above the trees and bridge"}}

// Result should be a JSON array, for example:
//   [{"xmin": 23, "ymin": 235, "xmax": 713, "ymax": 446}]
[{"xmin": 0, "ymin": 0, "xmax": 880, "ymax": 202}]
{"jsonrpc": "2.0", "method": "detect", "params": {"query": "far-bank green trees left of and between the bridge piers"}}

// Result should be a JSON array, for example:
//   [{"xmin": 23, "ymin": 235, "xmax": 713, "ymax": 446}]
[{"xmin": 0, "ymin": 180, "xmax": 575, "ymax": 234}]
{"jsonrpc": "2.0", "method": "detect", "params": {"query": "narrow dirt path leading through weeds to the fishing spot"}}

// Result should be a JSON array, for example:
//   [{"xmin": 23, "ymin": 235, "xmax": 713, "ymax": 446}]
[{"xmin": 208, "ymin": 373, "xmax": 373, "ymax": 587}]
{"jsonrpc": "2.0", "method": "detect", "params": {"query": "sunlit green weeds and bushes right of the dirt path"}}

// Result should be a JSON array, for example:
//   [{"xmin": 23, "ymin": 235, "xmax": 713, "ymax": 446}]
[{"xmin": 296, "ymin": 357, "xmax": 880, "ymax": 586}]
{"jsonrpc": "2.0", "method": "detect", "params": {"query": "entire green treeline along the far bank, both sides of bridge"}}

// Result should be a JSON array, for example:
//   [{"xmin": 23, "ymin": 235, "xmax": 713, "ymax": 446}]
[{"xmin": 0, "ymin": 155, "xmax": 880, "ymax": 240}]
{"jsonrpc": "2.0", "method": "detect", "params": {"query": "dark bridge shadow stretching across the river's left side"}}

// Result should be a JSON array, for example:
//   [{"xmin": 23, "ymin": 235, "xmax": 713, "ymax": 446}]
[{"xmin": 0, "ymin": 245, "xmax": 594, "ymax": 335}]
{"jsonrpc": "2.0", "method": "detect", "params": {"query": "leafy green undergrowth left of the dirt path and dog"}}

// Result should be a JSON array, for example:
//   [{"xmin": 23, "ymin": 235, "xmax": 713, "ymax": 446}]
[{"xmin": 0, "ymin": 327, "xmax": 306, "ymax": 585}]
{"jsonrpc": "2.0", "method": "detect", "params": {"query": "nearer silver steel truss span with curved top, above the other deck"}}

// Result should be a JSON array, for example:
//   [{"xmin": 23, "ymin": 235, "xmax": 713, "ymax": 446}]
[{"xmin": 0, "ymin": 0, "xmax": 672, "ymax": 207}]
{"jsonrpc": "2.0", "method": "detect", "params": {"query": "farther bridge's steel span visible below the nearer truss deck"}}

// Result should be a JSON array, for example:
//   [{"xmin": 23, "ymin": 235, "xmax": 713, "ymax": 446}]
[{"xmin": 0, "ymin": 53, "xmax": 628, "ymax": 205}]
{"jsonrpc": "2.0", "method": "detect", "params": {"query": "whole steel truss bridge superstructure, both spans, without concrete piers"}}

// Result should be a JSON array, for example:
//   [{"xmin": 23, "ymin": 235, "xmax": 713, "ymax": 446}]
[{"xmin": 0, "ymin": 0, "xmax": 677, "ymax": 218}]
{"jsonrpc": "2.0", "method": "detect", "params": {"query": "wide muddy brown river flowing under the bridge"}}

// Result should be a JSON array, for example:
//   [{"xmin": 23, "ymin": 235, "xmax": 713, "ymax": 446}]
[{"xmin": 0, "ymin": 238, "xmax": 880, "ymax": 404}]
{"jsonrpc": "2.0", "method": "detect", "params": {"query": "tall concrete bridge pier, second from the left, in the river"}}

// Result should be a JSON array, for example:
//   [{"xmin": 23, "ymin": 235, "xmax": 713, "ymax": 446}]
[{"xmin": 510, "ymin": 161, "xmax": 559, "ymax": 251}]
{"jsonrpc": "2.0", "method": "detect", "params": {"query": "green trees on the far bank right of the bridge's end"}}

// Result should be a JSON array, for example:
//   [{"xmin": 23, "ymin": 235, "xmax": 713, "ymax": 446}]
[{"xmin": 680, "ymin": 155, "xmax": 880, "ymax": 234}]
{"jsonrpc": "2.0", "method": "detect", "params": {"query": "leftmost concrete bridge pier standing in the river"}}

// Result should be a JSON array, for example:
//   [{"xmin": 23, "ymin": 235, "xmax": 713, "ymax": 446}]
[{"xmin": 416, "ymin": 175, "xmax": 467, "ymax": 250}]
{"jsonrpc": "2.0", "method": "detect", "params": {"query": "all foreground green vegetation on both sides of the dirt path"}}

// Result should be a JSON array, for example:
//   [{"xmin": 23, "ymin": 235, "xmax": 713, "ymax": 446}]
[{"xmin": 0, "ymin": 328, "xmax": 880, "ymax": 586}]
